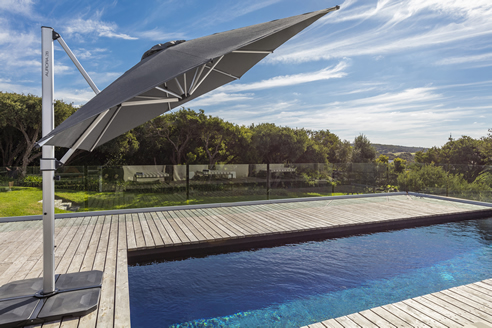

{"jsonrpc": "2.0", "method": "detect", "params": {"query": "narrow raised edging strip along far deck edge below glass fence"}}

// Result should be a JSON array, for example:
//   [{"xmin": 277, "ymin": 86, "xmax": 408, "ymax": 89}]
[{"xmin": 0, "ymin": 191, "xmax": 492, "ymax": 223}]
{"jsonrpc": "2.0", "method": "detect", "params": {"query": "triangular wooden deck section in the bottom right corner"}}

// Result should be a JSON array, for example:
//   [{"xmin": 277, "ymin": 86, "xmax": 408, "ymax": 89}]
[{"xmin": 303, "ymin": 279, "xmax": 492, "ymax": 328}]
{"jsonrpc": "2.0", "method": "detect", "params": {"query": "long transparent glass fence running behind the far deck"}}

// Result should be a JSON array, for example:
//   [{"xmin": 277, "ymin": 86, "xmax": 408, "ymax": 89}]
[{"xmin": 0, "ymin": 163, "xmax": 492, "ymax": 216}]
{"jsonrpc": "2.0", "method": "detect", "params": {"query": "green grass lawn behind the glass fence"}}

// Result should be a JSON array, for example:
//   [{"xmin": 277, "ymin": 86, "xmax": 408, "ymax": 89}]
[{"xmin": 0, "ymin": 187, "xmax": 344, "ymax": 217}]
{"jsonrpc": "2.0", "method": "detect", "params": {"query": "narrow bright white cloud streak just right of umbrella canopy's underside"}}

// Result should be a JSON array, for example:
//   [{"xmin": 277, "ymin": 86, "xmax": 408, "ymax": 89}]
[{"xmin": 220, "ymin": 61, "xmax": 348, "ymax": 92}]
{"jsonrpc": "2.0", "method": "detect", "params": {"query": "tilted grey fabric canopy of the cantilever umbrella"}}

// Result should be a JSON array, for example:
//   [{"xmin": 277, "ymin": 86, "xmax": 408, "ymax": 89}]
[{"xmin": 38, "ymin": 6, "xmax": 339, "ymax": 151}]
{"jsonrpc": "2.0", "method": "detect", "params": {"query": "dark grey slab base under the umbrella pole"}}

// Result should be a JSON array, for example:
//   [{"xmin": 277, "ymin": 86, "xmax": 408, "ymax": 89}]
[{"xmin": 0, "ymin": 270, "xmax": 102, "ymax": 328}]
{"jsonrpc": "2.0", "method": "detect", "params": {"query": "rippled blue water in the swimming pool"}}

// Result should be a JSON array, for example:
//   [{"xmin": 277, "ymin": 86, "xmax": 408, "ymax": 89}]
[{"xmin": 129, "ymin": 218, "xmax": 492, "ymax": 328}]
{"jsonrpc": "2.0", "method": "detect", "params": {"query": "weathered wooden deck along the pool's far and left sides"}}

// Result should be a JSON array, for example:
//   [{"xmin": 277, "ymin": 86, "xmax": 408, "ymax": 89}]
[{"xmin": 0, "ymin": 196, "xmax": 492, "ymax": 328}]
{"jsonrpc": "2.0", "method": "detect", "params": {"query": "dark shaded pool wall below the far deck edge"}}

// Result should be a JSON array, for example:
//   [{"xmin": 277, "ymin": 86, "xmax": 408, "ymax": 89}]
[{"xmin": 128, "ymin": 208, "xmax": 492, "ymax": 266}]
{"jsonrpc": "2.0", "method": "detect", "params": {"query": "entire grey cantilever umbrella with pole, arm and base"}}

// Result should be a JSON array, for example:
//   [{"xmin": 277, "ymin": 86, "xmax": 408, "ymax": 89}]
[{"xmin": 0, "ymin": 6, "xmax": 339, "ymax": 327}]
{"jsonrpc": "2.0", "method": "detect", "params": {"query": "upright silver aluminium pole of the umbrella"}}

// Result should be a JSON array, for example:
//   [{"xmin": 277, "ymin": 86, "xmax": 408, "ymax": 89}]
[{"xmin": 41, "ymin": 26, "xmax": 56, "ymax": 294}]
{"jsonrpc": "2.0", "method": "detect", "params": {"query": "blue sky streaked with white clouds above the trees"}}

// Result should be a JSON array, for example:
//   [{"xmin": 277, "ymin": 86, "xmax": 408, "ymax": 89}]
[{"xmin": 0, "ymin": 0, "xmax": 492, "ymax": 147}]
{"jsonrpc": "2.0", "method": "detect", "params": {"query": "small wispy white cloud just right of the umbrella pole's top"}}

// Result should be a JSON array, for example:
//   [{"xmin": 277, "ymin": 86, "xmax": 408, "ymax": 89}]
[{"xmin": 65, "ymin": 18, "xmax": 138, "ymax": 40}]
